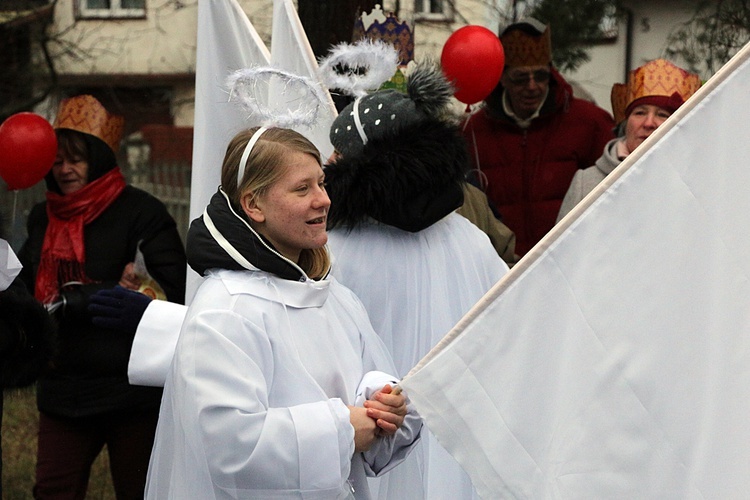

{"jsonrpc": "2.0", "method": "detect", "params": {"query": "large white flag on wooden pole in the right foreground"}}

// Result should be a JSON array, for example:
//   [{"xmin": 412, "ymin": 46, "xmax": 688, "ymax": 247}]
[{"xmin": 402, "ymin": 47, "xmax": 750, "ymax": 499}]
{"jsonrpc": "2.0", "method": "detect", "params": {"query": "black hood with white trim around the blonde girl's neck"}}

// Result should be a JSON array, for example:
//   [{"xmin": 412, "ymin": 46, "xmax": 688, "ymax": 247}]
[{"xmin": 186, "ymin": 189, "xmax": 307, "ymax": 281}]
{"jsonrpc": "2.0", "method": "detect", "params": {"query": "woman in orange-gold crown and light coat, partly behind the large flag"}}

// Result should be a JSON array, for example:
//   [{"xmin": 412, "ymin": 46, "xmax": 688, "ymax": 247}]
[{"xmin": 557, "ymin": 59, "xmax": 701, "ymax": 221}]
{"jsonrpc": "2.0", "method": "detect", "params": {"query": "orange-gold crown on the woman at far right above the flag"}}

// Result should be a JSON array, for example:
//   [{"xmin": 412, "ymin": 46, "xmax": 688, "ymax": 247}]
[{"xmin": 611, "ymin": 59, "xmax": 701, "ymax": 123}]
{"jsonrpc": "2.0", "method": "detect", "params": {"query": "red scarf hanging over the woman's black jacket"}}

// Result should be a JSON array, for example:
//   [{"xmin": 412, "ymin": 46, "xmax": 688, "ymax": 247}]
[{"xmin": 34, "ymin": 167, "xmax": 125, "ymax": 304}]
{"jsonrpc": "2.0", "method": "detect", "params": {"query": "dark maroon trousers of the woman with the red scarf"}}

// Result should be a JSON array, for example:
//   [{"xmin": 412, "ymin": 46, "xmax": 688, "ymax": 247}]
[{"xmin": 34, "ymin": 408, "xmax": 159, "ymax": 500}]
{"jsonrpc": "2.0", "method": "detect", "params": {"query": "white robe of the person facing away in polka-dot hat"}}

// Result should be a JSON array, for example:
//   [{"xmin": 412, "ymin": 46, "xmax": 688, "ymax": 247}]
[{"xmin": 328, "ymin": 213, "xmax": 508, "ymax": 500}]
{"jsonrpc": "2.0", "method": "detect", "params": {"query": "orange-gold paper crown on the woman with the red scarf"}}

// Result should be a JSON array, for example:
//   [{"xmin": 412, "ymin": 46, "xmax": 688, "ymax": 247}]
[{"xmin": 53, "ymin": 95, "xmax": 125, "ymax": 153}]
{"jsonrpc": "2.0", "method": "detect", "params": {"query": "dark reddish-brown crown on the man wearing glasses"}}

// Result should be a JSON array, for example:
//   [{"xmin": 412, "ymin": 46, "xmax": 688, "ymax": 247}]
[{"xmin": 500, "ymin": 19, "xmax": 552, "ymax": 67}]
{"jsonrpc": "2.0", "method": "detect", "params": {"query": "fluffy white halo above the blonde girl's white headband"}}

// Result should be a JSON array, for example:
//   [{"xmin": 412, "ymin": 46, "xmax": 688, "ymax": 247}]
[{"xmin": 226, "ymin": 66, "xmax": 328, "ymax": 128}]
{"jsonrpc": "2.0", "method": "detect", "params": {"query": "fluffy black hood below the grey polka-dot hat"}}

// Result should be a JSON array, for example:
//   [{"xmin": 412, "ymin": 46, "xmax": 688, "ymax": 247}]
[{"xmin": 325, "ymin": 120, "xmax": 468, "ymax": 232}]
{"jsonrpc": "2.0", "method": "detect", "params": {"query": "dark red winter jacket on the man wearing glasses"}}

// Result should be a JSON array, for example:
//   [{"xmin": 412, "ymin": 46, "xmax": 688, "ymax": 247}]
[{"xmin": 464, "ymin": 70, "xmax": 615, "ymax": 255}]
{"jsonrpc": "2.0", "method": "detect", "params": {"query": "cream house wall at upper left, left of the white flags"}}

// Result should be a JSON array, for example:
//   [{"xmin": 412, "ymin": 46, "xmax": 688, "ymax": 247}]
[{"xmin": 48, "ymin": 0, "xmax": 197, "ymax": 126}]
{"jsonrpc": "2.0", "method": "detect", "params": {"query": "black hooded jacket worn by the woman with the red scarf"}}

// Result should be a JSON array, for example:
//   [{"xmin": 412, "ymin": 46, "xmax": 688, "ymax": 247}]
[{"xmin": 18, "ymin": 132, "xmax": 185, "ymax": 417}]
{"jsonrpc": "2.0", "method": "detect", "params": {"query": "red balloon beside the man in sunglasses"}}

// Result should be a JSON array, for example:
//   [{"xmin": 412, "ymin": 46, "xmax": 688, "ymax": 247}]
[{"xmin": 440, "ymin": 25, "xmax": 505, "ymax": 104}]
